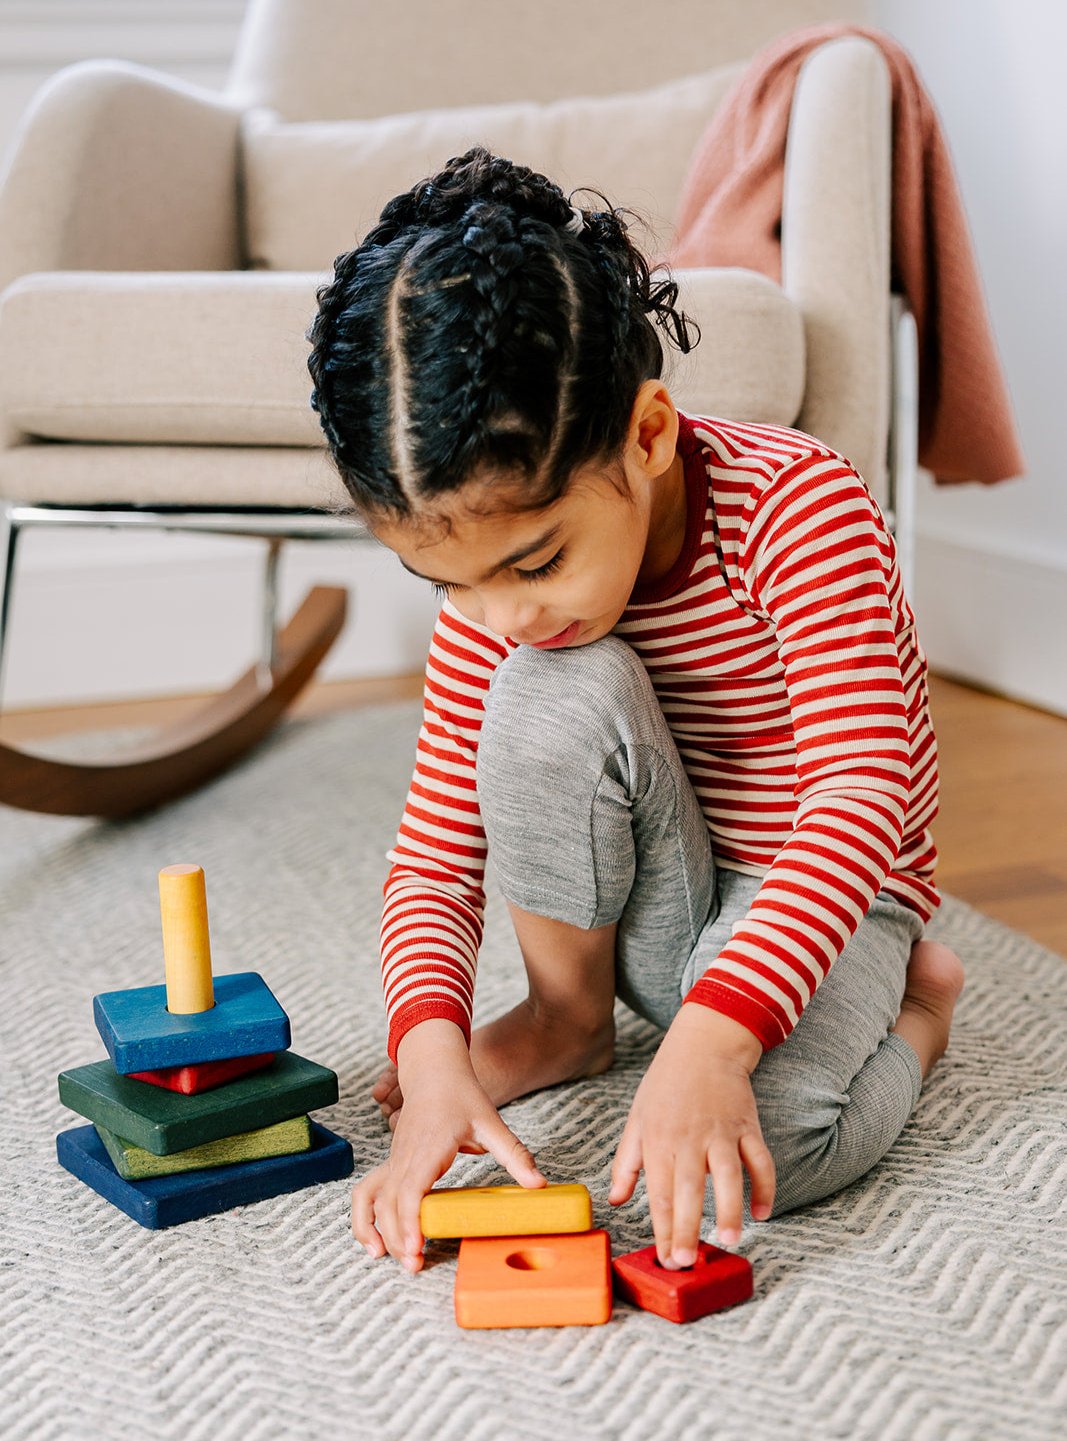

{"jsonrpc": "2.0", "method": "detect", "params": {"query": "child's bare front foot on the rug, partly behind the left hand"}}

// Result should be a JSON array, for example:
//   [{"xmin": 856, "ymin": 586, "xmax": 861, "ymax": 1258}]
[{"xmin": 371, "ymin": 1000, "xmax": 614, "ymax": 1128}]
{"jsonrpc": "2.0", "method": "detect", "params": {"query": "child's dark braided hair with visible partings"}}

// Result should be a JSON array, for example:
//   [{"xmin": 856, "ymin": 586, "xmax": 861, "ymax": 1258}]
[{"xmin": 307, "ymin": 146, "xmax": 699, "ymax": 519}]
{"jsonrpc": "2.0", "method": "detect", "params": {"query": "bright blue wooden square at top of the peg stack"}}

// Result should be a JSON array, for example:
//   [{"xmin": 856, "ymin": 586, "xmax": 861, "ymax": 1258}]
[{"xmin": 92, "ymin": 971, "xmax": 291, "ymax": 1076}]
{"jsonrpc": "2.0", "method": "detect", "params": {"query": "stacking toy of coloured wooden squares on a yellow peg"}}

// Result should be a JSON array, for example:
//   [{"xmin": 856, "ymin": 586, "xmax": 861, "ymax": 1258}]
[{"xmin": 56, "ymin": 866, "xmax": 353, "ymax": 1229}]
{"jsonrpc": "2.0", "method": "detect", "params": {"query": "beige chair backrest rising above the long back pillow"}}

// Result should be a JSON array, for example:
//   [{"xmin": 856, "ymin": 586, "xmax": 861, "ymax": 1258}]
[{"xmin": 228, "ymin": 0, "xmax": 869, "ymax": 120}]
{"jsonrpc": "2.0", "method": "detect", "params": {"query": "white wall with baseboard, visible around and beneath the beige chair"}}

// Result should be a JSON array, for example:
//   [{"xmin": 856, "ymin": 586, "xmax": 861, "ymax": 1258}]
[{"xmin": 0, "ymin": 0, "xmax": 1067, "ymax": 715}]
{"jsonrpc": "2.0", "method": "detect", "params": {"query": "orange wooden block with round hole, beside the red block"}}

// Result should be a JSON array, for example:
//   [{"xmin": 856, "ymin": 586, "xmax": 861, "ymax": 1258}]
[{"xmin": 456, "ymin": 1231, "xmax": 611, "ymax": 1330}]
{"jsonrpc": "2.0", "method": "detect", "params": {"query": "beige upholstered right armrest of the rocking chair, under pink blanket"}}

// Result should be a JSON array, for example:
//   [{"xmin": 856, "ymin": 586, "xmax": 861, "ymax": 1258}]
[{"xmin": 782, "ymin": 36, "xmax": 893, "ymax": 504}]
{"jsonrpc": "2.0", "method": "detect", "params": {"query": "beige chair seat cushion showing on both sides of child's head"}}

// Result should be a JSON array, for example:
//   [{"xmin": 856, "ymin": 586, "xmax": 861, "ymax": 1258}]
[{"xmin": 0, "ymin": 269, "xmax": 805, "ymax": 472}]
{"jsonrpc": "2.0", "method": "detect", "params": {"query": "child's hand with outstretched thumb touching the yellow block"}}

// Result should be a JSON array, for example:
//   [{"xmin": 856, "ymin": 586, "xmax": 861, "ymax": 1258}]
[{"xmin": 352, "ymin": 1020, "xmax": 546, "ymax": 1271}]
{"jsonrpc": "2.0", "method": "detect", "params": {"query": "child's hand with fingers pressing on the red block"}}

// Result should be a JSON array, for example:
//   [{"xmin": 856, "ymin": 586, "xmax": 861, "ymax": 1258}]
[{"xmin": 607, "ymin": 1003, "xmax": 774, "ymax": 1268}]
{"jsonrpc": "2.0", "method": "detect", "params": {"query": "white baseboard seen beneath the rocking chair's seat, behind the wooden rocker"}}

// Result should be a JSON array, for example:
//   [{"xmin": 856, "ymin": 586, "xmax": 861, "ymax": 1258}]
[{"xmin": 3, "ymin": 532, "xmax": 437, "ymax": 709}]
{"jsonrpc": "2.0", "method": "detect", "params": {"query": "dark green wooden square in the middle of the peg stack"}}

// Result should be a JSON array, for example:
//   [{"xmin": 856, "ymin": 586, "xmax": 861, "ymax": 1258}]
[{"xmin": 59, "ymin": 1050, "xmax": 337, "ymax": 1156}]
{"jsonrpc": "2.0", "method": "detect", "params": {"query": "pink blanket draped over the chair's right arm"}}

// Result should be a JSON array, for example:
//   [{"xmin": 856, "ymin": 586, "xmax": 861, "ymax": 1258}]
[{"xmin": 668, "ymin": 24, "xmax": 1025, "ymax": 483}]
